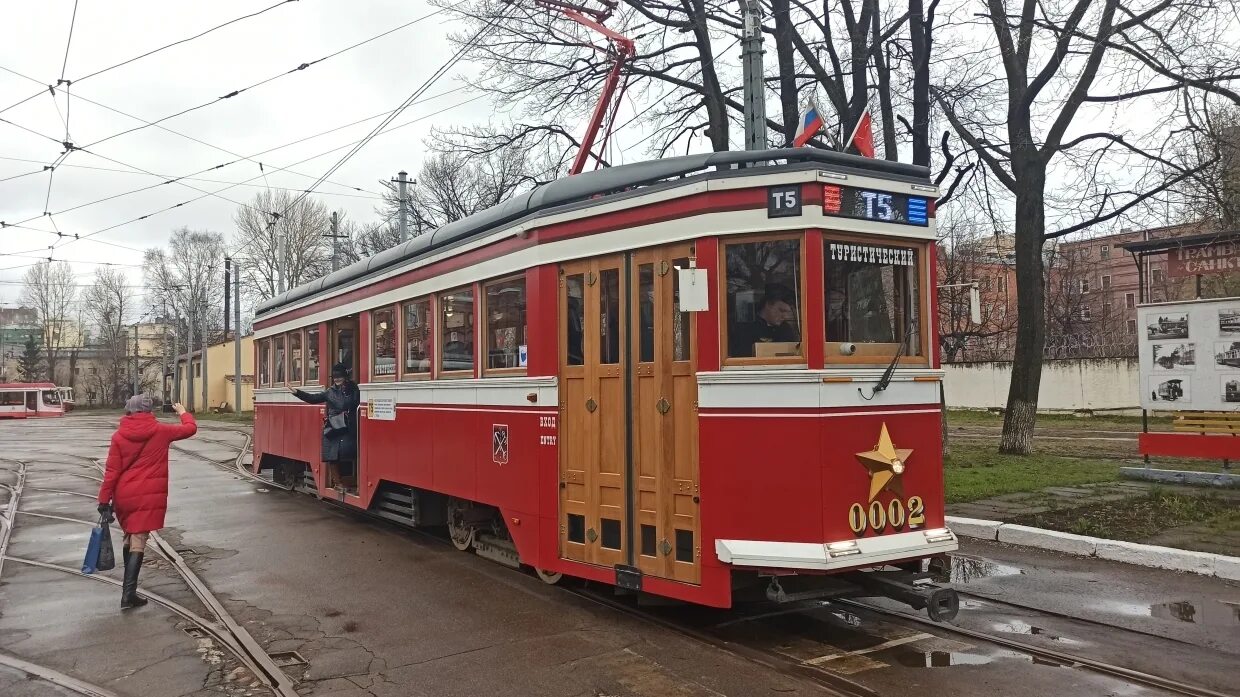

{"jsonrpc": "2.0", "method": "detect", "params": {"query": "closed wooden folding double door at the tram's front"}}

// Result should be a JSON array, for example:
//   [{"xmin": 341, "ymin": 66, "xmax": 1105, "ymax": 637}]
[{"xmin": 559, "ymin": 246, "xmax": 701, "ymax": 583}]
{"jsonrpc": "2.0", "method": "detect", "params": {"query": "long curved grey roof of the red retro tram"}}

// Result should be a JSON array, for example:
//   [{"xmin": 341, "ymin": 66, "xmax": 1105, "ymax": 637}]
[{"xmin": 254, "ymin": 148, "xmax": 930, "ymax": 317}]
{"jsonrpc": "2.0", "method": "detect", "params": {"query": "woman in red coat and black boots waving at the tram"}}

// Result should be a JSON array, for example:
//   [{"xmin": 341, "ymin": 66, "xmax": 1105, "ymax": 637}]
[{"xmin": 99, "ymin": 394, "xmax": 198, "ymax": 610}]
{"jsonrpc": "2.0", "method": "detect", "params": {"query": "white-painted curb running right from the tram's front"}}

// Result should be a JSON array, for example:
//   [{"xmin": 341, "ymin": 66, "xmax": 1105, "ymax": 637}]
[{"xmin": 946, "ymin": 516, "xmax": 1240, "ymax": 580}]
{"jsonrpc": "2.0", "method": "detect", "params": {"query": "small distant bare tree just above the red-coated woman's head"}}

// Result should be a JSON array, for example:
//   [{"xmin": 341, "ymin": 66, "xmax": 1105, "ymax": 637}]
[{"xmin": 82, "ymin": 267, "xmax": 136, "ymax": 404}]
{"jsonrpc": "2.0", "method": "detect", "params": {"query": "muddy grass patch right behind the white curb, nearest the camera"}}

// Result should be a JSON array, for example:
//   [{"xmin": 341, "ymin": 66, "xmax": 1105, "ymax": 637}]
[{"xmin": 1014, "ymin": 487, "xmax": 1240, "ymax": 542}]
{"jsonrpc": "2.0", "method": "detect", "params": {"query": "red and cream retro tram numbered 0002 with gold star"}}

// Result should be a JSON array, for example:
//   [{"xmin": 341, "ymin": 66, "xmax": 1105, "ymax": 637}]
[{"xmin": 254, "ymin": 149, "xmax": 957, "ymax": 616}]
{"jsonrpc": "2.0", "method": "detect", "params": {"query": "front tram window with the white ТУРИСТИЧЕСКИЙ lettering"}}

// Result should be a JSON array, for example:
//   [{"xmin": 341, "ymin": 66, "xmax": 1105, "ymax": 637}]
[{"xmin": 823, "ymin": 239, "xmax": 923, "ymax": 362}]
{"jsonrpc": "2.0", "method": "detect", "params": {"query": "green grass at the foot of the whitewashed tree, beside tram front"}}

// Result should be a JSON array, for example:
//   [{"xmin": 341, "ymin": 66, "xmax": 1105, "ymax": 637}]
[{"xmin": 944, "ymin": 440, "xmax": 1120, "ymax": 504}]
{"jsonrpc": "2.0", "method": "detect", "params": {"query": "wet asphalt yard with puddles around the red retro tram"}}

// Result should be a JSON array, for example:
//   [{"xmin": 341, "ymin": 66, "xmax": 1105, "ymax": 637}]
[{"xmin": 0, "ymin": 415, "xmax": 1240, "ymax": 697}]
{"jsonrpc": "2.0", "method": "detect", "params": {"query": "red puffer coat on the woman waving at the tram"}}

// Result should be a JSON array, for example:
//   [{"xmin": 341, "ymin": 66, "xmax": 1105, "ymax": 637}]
[{"xmin": 99, "ymin": 412, "xmax": 198, "ymax": 535}]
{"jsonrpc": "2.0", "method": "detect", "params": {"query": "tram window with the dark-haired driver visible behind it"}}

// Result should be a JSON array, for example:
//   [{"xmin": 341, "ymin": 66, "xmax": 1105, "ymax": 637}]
[{"xmin": 725, "ymin": 239, "xmax": 802, "ymax": 358}]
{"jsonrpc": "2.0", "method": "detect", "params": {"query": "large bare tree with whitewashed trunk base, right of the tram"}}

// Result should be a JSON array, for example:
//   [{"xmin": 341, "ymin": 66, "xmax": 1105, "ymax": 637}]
[{"xmin": 934, "ymin": 0, "xmax": 1240, "ymax": 454}]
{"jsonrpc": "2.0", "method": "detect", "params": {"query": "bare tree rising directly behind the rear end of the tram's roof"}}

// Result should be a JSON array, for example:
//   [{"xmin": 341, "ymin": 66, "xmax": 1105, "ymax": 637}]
[{"xmin": 233, "ymin": 191, "xmax": 331, "ymax": 301}]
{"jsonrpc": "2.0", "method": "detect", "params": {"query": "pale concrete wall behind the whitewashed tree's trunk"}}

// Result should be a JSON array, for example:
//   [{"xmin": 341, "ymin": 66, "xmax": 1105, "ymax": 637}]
[{"xmin": 944, "ymin": 358, "xmax": 1141, "ymax": 412}]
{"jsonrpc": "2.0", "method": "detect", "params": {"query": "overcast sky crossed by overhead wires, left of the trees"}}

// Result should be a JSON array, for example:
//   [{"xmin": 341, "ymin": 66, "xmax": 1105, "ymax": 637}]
[{"xmin": 0, "ymin": 0, "xmax": 513, "ymax": 305}]
